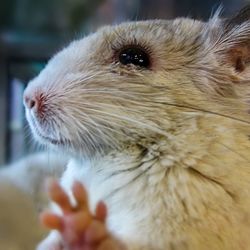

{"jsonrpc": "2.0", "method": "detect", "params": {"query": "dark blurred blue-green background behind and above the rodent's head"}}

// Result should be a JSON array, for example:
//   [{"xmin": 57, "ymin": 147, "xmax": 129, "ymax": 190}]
[{"xmin": 0, "ymin": 0, "xmax": 247, "ymax": 165}]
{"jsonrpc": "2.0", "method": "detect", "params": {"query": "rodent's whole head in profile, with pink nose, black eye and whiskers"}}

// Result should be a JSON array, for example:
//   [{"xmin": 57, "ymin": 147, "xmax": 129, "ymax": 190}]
[{"xmin": 24, "ymin": 7, "xmax": 250, "ymax": 158}]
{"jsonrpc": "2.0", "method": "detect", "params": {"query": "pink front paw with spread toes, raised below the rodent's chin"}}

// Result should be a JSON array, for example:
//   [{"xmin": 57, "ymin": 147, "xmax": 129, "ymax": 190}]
[{"xmin": 39, "ymin": 181, "xmax": 124, "ymax": 250}]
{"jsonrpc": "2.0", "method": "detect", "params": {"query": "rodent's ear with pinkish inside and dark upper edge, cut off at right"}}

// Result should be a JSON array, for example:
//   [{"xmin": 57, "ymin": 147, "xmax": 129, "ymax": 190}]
[{"xmin": 210, "ymin": 5, "xmax": 250, "ymax": 73}]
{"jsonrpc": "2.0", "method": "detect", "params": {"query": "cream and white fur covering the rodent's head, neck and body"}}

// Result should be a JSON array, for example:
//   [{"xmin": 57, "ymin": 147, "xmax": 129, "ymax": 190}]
[{"xmin": 25, "ymin": 11, "xmax": 250, "ymax": 250}]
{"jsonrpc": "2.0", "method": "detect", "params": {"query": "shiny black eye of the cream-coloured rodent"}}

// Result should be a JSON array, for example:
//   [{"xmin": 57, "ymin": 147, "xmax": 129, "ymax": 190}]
[{"xmin": 119, "ymin": 47, "xmax": 150, "ymax": 68}]
